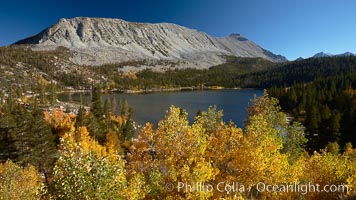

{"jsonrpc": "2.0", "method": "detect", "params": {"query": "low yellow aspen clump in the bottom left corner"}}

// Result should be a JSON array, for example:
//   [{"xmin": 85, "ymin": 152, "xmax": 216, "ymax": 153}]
[{"xmin": 0, "ymin": 161, "xmax": 45, "ymax": 200}]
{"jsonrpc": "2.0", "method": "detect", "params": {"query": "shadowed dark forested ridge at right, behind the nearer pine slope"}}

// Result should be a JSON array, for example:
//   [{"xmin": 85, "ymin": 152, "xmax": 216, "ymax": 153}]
[{"xmin": 236, "ymin": 56, "xmax": 356, "ymax": 88}]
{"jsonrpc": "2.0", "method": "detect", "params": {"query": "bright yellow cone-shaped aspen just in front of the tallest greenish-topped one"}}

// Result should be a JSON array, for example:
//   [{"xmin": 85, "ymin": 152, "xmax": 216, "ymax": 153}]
[{"xmin": 236, "ymin": 114, "xmax": 292, "ymax": 198}]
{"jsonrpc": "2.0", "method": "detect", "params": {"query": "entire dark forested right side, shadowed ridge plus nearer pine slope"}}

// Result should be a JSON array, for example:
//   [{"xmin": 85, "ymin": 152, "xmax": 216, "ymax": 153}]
[{"xmin": 245, "ymin": 56, "xmax": 356, "ymax": 151}]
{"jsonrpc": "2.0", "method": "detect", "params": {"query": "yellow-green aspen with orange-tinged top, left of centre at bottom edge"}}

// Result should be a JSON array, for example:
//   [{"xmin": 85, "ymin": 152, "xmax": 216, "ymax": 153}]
[{"xmin": 53, "ymin": 127, "xmax": 127, "ymax": 199}]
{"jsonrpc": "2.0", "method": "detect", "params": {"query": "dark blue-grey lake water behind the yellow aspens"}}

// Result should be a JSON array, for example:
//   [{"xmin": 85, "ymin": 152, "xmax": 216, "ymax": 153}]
[{"xmin": 62, "ymin": 89, "xmax": 263, "ymax": 127}]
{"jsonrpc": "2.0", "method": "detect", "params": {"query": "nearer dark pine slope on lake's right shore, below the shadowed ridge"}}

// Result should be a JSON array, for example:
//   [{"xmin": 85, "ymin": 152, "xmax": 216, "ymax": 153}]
[{"xmin": 269, "ymin": 73, "xmax": 356, "ymax": 150}]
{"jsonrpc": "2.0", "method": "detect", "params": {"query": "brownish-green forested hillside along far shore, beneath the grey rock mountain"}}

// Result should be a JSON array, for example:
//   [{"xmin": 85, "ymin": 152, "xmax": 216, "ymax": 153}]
[{"xmin": 0, "ymin": 45, "xmax": 277, "ymax": 97}]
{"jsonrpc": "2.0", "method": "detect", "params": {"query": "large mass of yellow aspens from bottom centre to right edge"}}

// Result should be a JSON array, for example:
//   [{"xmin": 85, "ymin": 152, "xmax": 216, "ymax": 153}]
[{"xmin": 126, "ymin": 94, "xmax": 355, "ymax": 199}]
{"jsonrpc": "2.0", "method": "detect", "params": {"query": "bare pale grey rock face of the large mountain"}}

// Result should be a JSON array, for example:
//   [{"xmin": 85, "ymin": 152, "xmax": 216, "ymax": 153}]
[{"xmin": 15, "ymin": 17, "xmax": 286, "ymax": 68}]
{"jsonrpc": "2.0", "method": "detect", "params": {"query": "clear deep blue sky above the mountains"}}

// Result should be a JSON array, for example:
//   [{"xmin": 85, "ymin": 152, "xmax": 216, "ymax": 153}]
[{"xmin": 0, "ymin": 0, "xmax": 356, "ymax": 60}]
